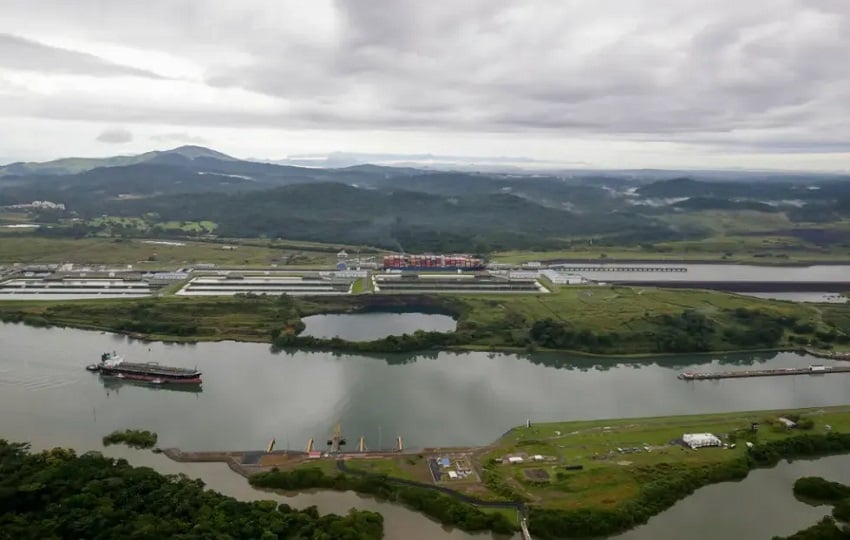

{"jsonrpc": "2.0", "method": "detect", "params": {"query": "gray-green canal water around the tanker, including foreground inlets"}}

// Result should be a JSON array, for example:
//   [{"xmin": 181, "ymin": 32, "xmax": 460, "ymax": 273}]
[{"xmin": 0, "ymin": 324, "xmax": 850, "ymax": 539}]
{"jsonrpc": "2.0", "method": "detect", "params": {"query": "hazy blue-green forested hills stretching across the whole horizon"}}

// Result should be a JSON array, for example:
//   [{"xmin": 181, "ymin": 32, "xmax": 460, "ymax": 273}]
[{"xmin": 0, "ymin": 147, "xmax": 850, "ymax": 253}]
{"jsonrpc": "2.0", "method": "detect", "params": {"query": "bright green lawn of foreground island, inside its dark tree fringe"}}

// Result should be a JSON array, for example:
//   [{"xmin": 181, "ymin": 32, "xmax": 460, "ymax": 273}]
[{"xmin": 274, "ymin": 405, "xmax": 850, "ymax": 519}]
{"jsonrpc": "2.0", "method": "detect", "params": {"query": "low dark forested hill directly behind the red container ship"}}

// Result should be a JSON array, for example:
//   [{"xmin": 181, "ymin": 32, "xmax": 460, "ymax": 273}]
[{"xmin": 79, "ymin": 183, "xmax": 664, "ymax": 251}]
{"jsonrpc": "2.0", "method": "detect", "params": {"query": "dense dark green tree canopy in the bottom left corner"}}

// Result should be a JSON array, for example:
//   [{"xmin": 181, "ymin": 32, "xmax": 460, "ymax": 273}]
[{"xmin": 0, "ymin": 440, "xmax": 383, "ymax": 540}]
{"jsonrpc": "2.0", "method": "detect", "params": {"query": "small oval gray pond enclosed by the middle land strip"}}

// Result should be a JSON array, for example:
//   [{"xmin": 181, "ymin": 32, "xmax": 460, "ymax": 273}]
[{"xmin": 303, "ymin": 313, "xmax": 457, "ymax": 341}]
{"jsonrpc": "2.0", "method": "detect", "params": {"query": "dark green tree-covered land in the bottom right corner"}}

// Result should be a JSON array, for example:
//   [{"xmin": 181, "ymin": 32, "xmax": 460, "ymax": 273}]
[{"xmin": 773, "ymin": 476, "xmax": 850, "ymax": 540}]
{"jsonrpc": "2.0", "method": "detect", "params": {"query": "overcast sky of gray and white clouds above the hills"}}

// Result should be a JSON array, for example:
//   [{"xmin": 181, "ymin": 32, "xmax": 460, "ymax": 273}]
[{"xmin": 0, "ymin": 0, "xmax": 850, "ymax": 171}]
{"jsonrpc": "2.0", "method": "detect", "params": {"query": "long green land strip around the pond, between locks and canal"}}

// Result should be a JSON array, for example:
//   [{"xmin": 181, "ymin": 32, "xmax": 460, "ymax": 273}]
[{"xmin": 0, "ymin": 286, "xmax": 850, "ymax": 355}]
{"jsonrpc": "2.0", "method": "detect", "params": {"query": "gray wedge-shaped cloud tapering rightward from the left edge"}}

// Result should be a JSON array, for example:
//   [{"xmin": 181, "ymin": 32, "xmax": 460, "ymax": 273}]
[{"xmin": 0, "ymin": 33, "xmax": 165, "ymax": 78}]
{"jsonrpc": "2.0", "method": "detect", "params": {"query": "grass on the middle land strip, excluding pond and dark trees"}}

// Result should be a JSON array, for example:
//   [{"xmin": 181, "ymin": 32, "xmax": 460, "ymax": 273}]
[{"xmin": 0, "ymin": 286, "xmax": 850, "ymax": 355}]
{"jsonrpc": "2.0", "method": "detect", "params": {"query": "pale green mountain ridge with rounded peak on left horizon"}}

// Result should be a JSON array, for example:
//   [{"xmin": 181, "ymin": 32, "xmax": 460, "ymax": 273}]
[{"xmin": 0, "ymin": 145, "xmax": 236, "ymax": 176}]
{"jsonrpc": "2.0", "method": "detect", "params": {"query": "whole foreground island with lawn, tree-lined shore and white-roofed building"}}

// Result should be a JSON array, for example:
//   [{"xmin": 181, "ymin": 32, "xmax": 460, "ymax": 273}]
[{"xmin": 176, "ymin": 406, "xmax": 850, "ymax": 539}]
